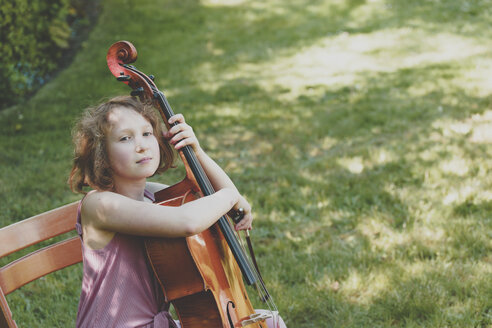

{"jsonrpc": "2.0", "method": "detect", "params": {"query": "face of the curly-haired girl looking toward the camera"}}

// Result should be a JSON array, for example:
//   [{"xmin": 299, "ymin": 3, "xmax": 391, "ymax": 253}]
[{"xmin": 106, "ymin": 107, "xmax": 160, "ymax": 185}]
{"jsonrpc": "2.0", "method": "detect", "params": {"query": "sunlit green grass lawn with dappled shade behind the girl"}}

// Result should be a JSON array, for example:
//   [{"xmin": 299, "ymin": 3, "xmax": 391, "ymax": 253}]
[{"xmin": 0, "ymin": 0, "xmax": 492, "ymax": 328}]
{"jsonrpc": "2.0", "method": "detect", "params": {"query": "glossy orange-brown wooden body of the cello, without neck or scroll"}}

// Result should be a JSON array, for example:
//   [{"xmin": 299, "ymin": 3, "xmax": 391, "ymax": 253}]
[{"xmin": 145, "ymin": 179, "xmax": 266, "ymax": 328}]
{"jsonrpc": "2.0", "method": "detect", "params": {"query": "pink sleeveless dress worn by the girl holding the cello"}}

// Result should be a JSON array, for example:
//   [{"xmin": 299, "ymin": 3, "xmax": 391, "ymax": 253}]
[{"xmin": 76, "ymin": 190, "xmax": 179, "ymax": 328}]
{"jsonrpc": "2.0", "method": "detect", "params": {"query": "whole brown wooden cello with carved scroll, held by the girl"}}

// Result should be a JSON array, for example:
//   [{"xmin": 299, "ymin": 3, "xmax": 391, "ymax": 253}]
[{"xmin": 106, "ymin": 41, "xmax": 278, "ymax": 328}]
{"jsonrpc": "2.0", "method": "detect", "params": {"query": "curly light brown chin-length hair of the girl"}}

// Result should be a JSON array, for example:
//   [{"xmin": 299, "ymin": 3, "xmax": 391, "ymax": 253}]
[{"xmin": 68, "ymin": 96, "xmax": 176, "ymax": 193}]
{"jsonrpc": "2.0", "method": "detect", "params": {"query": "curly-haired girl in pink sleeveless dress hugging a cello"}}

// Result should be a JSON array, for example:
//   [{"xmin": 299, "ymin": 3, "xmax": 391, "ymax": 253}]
[{"xmin": 69, "ymin": 96, "xmax": 284, "ymax": 328}]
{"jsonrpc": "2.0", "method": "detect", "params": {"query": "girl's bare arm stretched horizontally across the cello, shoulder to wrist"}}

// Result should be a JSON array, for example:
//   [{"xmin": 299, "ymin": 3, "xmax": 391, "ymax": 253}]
[{"xmin": 82, "ymin": 188, "xmax": 240, "ymax": 237}]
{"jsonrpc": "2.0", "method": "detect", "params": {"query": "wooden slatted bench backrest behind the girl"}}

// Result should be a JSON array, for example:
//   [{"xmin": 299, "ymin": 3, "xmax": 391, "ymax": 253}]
[{"xmin": 0, "ymin": 202, "xmax": 82, "ymax": 328}]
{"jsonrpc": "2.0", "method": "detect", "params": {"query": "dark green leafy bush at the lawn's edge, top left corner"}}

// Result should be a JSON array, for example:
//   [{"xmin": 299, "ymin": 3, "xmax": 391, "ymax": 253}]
[{"xmin": 0, "ymin": 0, "xmax": 95, "ymax": 109}]
